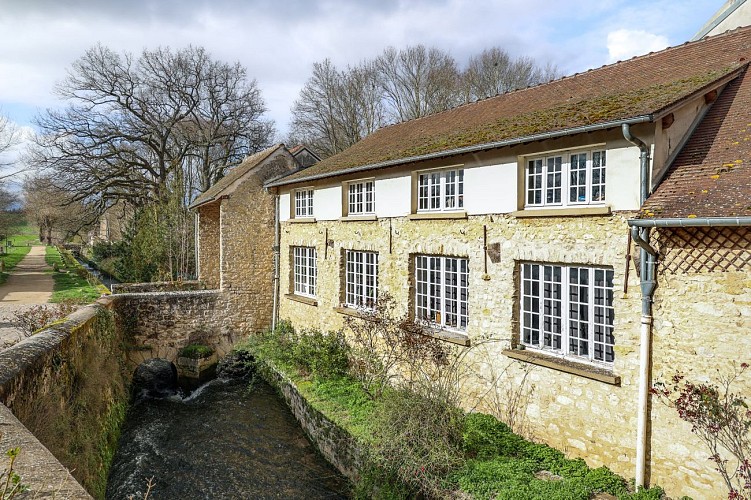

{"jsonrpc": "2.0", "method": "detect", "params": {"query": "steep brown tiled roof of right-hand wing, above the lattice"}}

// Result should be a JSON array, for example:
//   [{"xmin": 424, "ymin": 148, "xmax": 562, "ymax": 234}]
[{"xmin": 641, "ymin": 71, "xmax": 751, "ymax": 219}]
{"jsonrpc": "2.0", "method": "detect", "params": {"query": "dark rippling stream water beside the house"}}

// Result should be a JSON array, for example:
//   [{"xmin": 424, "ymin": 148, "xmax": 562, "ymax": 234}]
[{"xmin": 106, "ymin": 379, "xmax": 349, "ymax": 500}]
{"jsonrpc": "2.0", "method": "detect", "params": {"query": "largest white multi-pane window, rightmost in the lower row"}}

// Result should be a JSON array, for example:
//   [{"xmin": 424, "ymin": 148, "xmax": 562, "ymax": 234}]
[{"xmin": 520, "ymin": 263, "xmax": 615, "ymax": 363}]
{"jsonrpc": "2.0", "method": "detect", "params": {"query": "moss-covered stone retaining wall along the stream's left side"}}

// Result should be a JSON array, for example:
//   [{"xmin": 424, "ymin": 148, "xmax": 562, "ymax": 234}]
[{"xmin": 0, "ymin": 299, "xmax": 132, "ymax": 498}]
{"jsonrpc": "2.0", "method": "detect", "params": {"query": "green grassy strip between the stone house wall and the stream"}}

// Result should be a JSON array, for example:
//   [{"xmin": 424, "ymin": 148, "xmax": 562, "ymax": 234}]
[{"xmin": 240, "ymin": 324, "xmax": 663, "ymax": 500}]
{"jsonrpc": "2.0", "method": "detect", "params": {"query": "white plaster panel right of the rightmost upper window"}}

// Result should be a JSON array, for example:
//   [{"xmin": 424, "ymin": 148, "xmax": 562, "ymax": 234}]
[{"xmin": 605, "ymin": 146, "xmax": 640, "ymax": 210}]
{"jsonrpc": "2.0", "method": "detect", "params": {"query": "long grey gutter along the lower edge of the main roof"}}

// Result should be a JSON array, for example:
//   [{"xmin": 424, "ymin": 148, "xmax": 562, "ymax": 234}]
[{"xmin": 264, "ymin": 114, "xmax": 654, "ymax": 188}]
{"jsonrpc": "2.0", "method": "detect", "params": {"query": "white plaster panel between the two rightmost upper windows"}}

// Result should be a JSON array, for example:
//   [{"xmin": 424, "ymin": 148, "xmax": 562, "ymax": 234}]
[{"xmin": 464, "ymin": 162, "xmax": 517, "ymax": 215}]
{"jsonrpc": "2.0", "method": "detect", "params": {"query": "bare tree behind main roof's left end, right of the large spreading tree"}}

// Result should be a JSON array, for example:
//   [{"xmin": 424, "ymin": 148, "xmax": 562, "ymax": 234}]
[{"xmin": 290, "ymin": 59, "xmax": 383, "ymax": 157}]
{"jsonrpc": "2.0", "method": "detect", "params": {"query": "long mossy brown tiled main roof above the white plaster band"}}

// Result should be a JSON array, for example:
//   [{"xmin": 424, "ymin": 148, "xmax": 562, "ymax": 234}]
[{"xmin": 273, "ymin": 28, "xmax": 751, "ymax": 185}]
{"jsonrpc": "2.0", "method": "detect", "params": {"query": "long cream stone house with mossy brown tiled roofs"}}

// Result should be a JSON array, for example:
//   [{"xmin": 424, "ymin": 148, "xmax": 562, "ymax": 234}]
[{"xmin": 194, "ymin": 28, "xmax": 751, "ymax": 498}]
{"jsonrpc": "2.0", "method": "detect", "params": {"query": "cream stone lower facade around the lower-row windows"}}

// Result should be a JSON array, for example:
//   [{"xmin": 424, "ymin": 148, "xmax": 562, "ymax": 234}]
[{"xmin": 280, "ymin": 213, "xmax": 744, "ymax": 496}]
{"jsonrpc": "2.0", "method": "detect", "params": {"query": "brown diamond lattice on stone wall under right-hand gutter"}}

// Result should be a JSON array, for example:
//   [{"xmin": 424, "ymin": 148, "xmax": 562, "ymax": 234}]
[{"xmin": 653, "ymin": 227, "xmax": 751, "ymax": 274}]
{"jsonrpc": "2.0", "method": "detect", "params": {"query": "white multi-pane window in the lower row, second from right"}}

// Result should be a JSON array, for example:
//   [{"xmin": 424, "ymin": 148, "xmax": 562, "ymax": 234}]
[{"xmin": 415, "ymin": 255, "xmax": 469, "ymax": 331}]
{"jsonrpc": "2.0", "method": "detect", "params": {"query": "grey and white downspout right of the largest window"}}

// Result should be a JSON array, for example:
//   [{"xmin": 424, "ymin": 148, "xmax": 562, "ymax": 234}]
[{"xmin": 621, "ymin": 123, "xmax": 657, "ymax": 490}]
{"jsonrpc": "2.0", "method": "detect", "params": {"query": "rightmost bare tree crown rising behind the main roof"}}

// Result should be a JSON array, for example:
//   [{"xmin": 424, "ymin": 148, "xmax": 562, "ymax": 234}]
[{"xmin": 462, "ymin": 47, "xmax": 558, "ymax": 102}]
